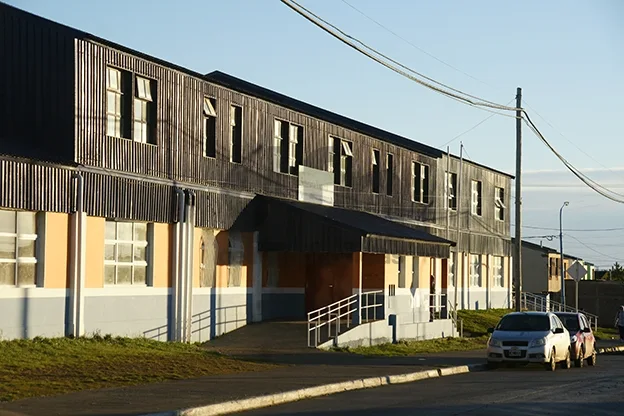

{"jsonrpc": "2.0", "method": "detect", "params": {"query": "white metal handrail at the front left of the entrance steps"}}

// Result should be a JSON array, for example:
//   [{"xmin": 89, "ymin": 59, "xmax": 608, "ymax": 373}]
[{"xmin": 308, "ymin": 290, "xmax": 384, "ymax": 347}]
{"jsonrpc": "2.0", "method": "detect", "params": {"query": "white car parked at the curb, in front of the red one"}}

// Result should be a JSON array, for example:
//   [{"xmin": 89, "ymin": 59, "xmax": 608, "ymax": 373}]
[{"xmin": 487, "ymin": 312, "xmax": 571, "ymax": 371}]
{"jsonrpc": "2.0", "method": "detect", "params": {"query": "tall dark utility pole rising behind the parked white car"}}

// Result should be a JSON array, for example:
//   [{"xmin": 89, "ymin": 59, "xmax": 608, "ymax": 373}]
[{"xmin": 512, "ymin": 87, "xmax": 522, "ymax": 312}]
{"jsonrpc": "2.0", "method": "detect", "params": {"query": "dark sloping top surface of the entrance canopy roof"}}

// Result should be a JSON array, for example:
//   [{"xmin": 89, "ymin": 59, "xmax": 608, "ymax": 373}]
[{"xmin": 263, "ymin": 196, "xmax": 455, "ymax": 246}]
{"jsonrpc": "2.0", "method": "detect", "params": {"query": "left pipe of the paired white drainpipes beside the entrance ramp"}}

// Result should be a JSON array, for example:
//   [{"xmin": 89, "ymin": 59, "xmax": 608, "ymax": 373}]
[{"xmin": 172, "ymin": 188, "xmax": 186, "ymax": 341}]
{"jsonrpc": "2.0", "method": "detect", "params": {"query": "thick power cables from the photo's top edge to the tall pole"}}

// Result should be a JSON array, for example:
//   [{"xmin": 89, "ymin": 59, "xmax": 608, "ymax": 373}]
[{"xmin": 281, "ymin": 0, "xmax": 517, "ymax": 114}]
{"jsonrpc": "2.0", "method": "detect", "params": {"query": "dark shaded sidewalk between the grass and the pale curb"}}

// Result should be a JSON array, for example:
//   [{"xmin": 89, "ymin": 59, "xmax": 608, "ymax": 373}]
[{"xmin": 0, "ymin": 351, "xmax": 484, "ymax": 416}]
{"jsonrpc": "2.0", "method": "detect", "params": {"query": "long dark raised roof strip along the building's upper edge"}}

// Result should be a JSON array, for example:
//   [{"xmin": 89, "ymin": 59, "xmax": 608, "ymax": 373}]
[{"xmin": 204, "ymin": 71, "xmax": 444, "ymax": 158}]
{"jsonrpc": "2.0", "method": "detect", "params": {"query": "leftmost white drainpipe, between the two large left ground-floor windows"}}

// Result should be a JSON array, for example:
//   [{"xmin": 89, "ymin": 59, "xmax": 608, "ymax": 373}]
[{"xmin": 68, "ymin": 172, "xmax": 86, "ymax": 337}]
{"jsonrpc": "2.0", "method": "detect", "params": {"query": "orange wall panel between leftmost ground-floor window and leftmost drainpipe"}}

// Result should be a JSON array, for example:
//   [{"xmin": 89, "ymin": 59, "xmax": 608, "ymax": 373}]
[{"xmin": 43, "ymin": 212, "xmax": 70, "ymax": 289}]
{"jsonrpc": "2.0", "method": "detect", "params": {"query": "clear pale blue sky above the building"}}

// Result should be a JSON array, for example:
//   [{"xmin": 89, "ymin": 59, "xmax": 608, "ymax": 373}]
[{"xmin": 4, "ymin": 0, "xmax": 624, "ymax": 266}]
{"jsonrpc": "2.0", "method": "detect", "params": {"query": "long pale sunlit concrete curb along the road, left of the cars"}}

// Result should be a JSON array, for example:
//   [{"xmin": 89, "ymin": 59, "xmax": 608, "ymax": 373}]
[{"xmin": 142, "ymin": 364, "xmax": 487, "ymax": 416}]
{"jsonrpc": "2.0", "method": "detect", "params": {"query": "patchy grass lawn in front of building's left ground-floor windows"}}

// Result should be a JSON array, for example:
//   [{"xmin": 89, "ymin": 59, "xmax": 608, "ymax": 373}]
[{"xmin": 0, "ymin": 336, "xmax": 275, "ymax": 401}]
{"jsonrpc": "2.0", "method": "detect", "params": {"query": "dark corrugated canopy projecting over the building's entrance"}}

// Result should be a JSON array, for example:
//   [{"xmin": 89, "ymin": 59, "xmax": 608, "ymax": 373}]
[{"xmin": 235, "ymin": 195, "xmax": 455, "ymax": 258}]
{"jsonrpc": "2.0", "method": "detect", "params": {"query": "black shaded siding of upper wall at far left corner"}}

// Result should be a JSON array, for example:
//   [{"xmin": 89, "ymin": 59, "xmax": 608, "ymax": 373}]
[{"xmin": 0, "ymin": 3, "xmax": 74, "ymax": 162}]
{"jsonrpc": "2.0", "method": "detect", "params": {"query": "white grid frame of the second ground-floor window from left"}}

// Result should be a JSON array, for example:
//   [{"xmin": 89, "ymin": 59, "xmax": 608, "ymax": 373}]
[{"xmin": 104, "ymin": 220, "xmax": 150, "ymax": 286}]
